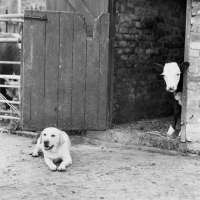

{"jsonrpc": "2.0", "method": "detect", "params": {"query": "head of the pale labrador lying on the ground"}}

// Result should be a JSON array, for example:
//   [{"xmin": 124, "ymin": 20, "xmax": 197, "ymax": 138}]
[{"xmin": 40, "ymin": 127, "xmax": 65, "ymax": 151}]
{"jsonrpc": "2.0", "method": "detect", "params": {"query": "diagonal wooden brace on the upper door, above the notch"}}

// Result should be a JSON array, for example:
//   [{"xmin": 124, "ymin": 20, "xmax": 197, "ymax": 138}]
[{"xmin": 68, "ymin": 0, "xmax": 94, "ymax": 25}]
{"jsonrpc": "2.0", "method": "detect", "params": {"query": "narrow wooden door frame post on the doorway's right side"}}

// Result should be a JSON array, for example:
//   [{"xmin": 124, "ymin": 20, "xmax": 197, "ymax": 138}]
[{"xmin": 181, "ymin": 0, "xmax": 192, "ymax": 142}]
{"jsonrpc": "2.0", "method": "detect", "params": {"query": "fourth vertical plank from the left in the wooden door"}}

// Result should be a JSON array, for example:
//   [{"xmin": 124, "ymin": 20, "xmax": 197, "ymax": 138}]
[{"xmin": 58, "ymin": 12, "xmax": 74, "ymax": 130}]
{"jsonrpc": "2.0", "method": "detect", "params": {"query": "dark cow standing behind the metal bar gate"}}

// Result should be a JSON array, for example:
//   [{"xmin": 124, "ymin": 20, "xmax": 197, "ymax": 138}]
[{"xmin": 0, "ymin": 33, "xmax": 21, "ymax": 104}]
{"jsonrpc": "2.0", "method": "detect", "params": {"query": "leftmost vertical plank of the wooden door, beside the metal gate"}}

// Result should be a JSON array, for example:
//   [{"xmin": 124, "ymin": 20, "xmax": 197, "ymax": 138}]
[{"xmin": 20, "ymin": 10, "xmax": 33, "ymax": 130}]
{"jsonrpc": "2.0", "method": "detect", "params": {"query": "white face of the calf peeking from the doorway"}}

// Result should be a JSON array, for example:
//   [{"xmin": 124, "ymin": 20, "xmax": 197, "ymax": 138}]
[{"xmin": 161, "ymin": 62, "xmax": 181, "ymax": 92}]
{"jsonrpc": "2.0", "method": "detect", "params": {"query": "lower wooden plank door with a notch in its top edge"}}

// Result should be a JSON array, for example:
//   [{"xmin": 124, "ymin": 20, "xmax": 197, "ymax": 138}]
[{"xmin": 21, "ymin": 10, "xmax": 109, "ymax": 130}]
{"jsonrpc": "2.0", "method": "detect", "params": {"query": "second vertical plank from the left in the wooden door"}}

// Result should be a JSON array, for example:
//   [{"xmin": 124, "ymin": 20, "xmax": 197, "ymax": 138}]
[{"xmin": 31, "ymin": 11, "xmax": 45, "ymax": 130}]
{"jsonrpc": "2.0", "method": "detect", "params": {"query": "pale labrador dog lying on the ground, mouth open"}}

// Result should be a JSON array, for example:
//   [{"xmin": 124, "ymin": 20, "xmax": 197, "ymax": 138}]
[{"xmin": 32, "ymin": 127, "xmax": 72, "ymax": 171}]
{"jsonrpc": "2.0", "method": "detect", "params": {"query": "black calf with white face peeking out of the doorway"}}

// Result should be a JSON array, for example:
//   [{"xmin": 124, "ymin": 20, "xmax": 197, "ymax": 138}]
[{"xmin": 157, "ymin": 62, "xmax": 189, "ymax": 136}]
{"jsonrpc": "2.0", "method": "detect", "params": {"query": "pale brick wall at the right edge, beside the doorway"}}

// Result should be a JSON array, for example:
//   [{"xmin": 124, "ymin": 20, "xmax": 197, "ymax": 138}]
[{"xmin": 186, "ymin": 0, "xmax": 200, "ymax": 145}]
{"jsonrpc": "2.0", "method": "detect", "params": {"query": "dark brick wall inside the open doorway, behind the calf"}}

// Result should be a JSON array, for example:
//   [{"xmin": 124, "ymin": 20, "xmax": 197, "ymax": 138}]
[{"xmin": 114, "ymin": 0, "xmax": 186, "ymax": 123}]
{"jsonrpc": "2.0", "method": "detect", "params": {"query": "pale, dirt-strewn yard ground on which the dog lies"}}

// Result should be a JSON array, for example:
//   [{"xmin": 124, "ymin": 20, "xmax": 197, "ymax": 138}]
[{"xmin": 0, "ymin": 132, "xmax": 200, "ymax": 200}]
